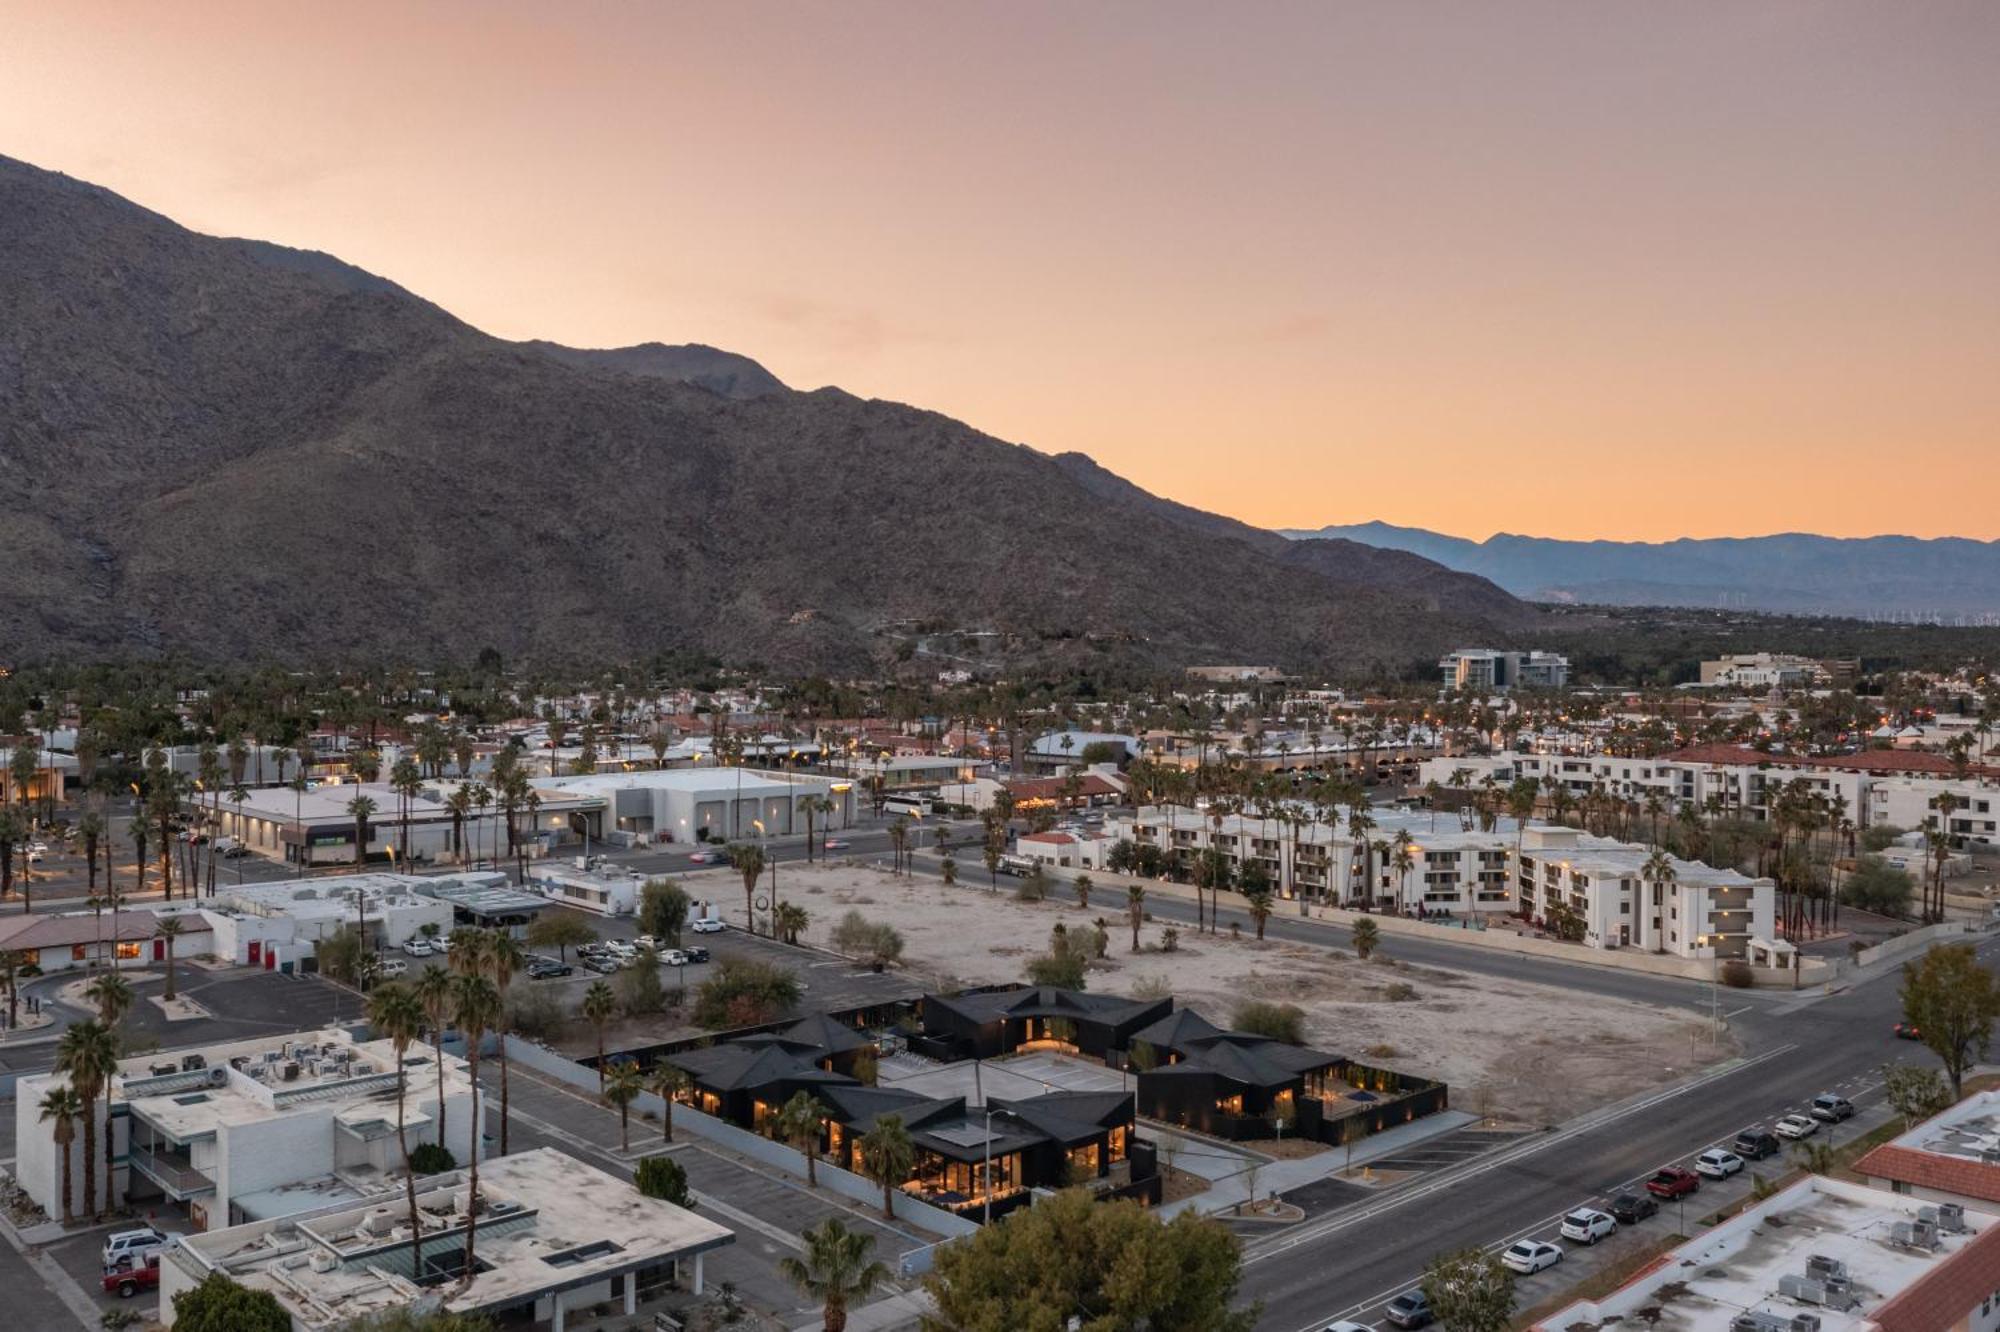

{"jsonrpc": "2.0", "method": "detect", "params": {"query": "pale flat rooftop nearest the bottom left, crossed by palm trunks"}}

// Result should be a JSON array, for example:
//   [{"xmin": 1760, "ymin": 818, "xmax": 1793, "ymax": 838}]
[{"xmin": 168, "ymin": 1148, "xmax": 736, "ymax": 1328}]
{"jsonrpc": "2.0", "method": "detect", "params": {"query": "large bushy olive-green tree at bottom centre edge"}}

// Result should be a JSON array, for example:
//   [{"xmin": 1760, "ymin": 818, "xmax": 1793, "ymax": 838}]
[{"xmin": 924, "ymin": 1188, "xmax": 1262, "ymax": 1332}]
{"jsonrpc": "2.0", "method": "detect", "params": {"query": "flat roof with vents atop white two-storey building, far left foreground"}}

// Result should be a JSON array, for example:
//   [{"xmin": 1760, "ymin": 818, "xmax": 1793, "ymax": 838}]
[{"xmin": 116, "ymin": 1028, "xmax": 472, "ymax": 1142}]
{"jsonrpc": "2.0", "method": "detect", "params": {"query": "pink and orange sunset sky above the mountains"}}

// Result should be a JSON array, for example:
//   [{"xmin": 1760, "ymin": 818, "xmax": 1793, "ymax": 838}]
[{"xmin": 0, "ymin": 0, "xmax": 2000, "ymax": 540}]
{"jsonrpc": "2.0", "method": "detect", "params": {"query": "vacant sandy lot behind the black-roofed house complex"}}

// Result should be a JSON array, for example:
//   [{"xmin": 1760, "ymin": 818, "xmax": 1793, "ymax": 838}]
[{"xmin": 772, "ymin": 866, "xmax": 1732, "ymax": 1124}]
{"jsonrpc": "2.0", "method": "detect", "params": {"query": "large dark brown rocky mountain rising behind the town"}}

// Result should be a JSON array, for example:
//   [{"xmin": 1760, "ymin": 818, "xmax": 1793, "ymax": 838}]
[{"xmin": 0, "ymin": 158, "xmax": 1544, "ymax": 672}]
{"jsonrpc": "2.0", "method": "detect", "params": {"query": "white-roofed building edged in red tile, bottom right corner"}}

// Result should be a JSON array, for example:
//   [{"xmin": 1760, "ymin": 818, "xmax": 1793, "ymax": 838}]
[{"xmin": 1534, "ymin": 1174, "xmax": 2000, "ymax": 1332}]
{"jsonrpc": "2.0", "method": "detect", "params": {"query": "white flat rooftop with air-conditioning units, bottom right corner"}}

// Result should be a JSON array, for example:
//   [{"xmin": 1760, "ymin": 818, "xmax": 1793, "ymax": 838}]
[{"xmin": 1536, "ymin": 1176, "xmax": 2000, "ymax": 1332}]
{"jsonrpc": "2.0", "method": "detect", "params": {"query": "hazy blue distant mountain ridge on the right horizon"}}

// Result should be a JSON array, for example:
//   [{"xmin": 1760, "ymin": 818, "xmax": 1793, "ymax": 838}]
[{"xmin": 1284, "ymin": 522, "xmax": 2000, "ymax": 622}]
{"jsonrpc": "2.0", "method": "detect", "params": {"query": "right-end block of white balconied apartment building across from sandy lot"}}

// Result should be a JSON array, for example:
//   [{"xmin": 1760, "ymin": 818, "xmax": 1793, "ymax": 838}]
[{"xmin": 1514, "ymin": 824, "xmax": 1790, "ymax": 958}]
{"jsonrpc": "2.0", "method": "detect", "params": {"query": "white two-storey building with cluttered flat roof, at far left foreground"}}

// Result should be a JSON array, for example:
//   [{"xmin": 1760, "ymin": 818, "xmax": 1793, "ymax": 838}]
[{"xmin": 14, "ymin": 1028, "xmax": 484, "ymax": 1230}]
